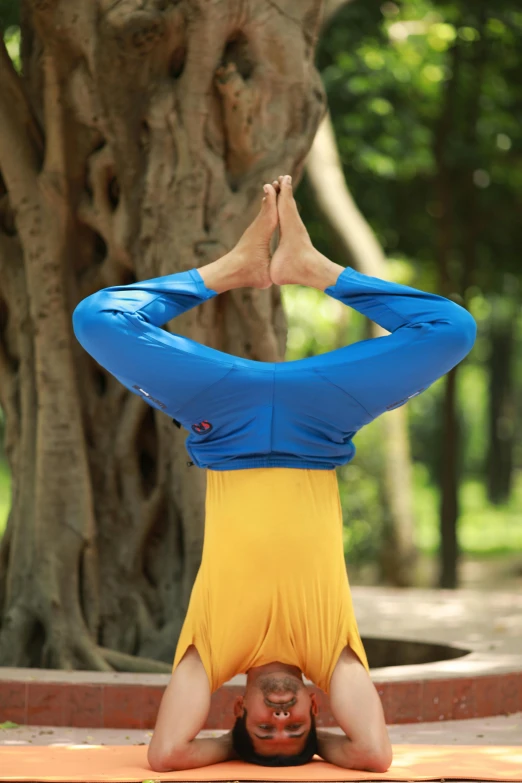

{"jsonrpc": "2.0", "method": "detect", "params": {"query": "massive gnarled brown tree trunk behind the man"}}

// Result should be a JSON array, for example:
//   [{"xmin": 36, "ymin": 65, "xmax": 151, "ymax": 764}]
[{"xmin": 0, "ymin": 0, "xmax": 325, "ymax": 671}]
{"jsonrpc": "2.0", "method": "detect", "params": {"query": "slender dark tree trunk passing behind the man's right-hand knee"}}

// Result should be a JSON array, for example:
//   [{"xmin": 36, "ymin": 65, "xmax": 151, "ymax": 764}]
[{"xmin": 433, "ymin": 16, "xmax": 482, "ymax": 588}]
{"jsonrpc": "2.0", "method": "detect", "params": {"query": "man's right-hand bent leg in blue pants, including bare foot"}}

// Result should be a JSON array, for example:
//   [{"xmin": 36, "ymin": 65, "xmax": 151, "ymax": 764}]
[{"xmin": 270, "ymin": 178, "xmax": 476, "ymax": 430}]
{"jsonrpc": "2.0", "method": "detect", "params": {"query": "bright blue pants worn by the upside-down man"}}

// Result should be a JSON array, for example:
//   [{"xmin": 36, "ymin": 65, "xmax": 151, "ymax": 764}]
[{"xmin": 73, "ymin": 269, "xmax": 476, "ymax": 470}]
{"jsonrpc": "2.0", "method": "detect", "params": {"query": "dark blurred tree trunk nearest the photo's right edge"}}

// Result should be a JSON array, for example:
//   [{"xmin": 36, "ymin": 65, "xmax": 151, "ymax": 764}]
[{"xmin": 486, "ymin": 294, "xmax": 516, "ymax": 505}]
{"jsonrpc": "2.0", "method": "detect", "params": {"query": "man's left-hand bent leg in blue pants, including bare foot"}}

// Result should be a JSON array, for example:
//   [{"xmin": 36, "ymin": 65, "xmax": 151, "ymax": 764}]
[{"xmin": 73, "ymin": 186, "xmax": 277, "ymax": 417}]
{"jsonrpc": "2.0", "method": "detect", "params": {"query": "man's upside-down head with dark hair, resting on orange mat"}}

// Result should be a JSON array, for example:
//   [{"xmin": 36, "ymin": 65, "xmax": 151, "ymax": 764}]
[{"xmin": 232, "ymin": 667, "xmax": 317, "ymax": 767}]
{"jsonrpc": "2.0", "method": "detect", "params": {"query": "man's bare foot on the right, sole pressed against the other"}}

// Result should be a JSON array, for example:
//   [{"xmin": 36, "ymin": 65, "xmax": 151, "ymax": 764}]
[{"xmin": 270, "ymin": 175, "xmax": 343, "ymax": 291}]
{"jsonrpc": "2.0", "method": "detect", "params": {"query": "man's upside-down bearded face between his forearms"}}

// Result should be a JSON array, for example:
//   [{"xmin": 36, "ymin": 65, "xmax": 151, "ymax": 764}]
[{"xmin": 236, "ymin": 673, "xmax": 317, "ymax": 756}]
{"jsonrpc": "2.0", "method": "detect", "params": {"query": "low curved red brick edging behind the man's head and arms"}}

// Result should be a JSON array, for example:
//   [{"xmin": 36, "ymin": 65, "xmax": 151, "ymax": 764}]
[{"xmin": 0, "ymin": 669, "xmax": 522, "ymax": 729}]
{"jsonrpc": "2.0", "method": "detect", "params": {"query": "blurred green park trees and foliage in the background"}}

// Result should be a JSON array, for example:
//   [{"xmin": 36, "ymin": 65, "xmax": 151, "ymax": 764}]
[{"xmin": 0, "ymin": 0, "xmax": 522, "ymax": 672}]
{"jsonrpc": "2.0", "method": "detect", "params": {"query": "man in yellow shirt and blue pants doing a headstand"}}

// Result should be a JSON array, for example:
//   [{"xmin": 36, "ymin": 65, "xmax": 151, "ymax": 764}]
[{"xmin": 73, "ymin": 176, "xmax": 476, "ymax": 772}]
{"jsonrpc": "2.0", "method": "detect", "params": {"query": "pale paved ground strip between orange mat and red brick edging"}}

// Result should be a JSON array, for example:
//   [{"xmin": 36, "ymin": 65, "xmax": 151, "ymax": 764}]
[{"xmin": 0, "ymin": 713, "xmax": 522, "ymax": 745}]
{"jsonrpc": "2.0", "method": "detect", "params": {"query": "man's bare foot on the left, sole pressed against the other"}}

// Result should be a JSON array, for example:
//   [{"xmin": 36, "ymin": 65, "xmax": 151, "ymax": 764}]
[{"xmin": 199, "ymin": 181, "xmax": 279, "ymax": 293}]
